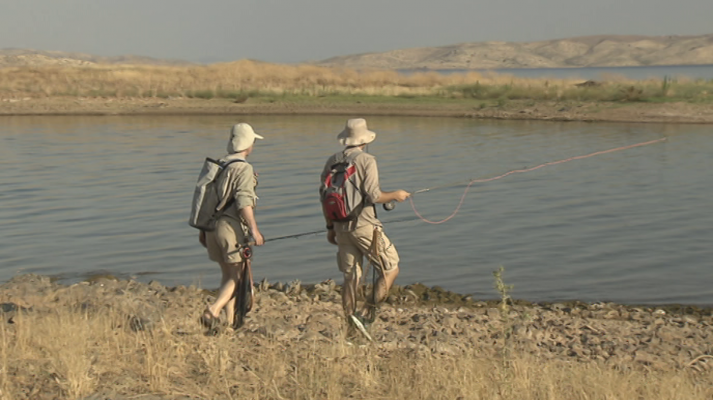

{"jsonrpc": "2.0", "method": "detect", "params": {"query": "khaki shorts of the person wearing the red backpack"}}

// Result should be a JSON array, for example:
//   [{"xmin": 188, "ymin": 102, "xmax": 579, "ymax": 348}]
[{"xmin": 337, "ymin": 225, "xmax": 399, "ymax": 279}]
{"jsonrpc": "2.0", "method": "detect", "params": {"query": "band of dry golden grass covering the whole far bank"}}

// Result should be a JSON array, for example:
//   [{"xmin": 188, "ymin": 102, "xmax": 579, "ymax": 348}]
[{"xmin": 0, "ymin": 60, "xmax": 713, "ymax": 101}]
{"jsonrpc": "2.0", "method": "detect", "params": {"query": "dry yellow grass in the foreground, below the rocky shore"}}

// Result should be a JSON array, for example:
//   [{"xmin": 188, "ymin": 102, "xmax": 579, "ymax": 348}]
[{"xmin": 0, "ymin": 308, "xmax": 713, "ymax": 400}]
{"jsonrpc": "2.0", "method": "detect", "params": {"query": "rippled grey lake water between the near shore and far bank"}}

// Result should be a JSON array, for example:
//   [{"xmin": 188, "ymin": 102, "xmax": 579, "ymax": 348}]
[{"xmin": 0, "ymin": 116, "xmax": 713, "ymax": 305}]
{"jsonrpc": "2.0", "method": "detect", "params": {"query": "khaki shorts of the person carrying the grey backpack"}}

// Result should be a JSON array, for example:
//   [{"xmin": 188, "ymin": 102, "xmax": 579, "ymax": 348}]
[{"xmin": 205, "ymin": 217, "xmax": 247, "ymax": 264}]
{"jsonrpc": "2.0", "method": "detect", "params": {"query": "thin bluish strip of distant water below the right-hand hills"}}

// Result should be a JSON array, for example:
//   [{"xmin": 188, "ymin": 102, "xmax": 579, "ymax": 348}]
[{"xmin": 404, "ymin": 64, "xmax": 713, "ymax": 81}]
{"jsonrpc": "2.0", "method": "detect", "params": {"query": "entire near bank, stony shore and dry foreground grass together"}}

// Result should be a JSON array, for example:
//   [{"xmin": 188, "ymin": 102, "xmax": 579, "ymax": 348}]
[{"xmin": 0, "ymin": 271, "xmax": 713, "ymax": 400}]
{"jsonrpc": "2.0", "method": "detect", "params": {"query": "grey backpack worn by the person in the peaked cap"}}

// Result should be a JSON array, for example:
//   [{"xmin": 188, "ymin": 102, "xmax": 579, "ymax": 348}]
[{"xmin": 188, "ymin": 158, "xmax": 246, "ymax": 231}]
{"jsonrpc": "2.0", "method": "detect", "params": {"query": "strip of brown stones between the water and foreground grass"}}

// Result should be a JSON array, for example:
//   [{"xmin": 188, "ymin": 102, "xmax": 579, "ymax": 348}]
[{"xmin": 0, "ymin": 275, "xmax": 713, "ymax": 371}]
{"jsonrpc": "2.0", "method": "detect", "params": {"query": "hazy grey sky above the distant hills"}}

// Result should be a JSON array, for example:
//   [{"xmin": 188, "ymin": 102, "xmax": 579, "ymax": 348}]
[{"xmin": 0, "ymin": 0, "xmax": 713, "ymax": 62}]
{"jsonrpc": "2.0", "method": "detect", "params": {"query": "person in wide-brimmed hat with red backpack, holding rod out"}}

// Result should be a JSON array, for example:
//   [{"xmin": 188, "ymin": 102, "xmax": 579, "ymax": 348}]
[{"xmin": 319, "ymin": 118, "xmax": 410, "ymax": 338}]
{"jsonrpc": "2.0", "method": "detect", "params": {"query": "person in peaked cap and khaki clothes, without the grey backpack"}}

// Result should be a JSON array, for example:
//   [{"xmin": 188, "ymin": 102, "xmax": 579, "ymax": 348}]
[{"xmin": 191, "ymin": 123, "xmax": 264, "ymax": 328}]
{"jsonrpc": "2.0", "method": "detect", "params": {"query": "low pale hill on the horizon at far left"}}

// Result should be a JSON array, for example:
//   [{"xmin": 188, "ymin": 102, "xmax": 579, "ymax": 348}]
[{"xmin": 0, "ymin": 49, "xmax": 194, "ymax": 68}]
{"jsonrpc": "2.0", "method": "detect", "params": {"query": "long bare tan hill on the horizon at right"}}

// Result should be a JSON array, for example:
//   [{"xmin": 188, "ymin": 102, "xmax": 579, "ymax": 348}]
[{"xmin": 316, "ymin": 34, "xmax": 713, "ymax": 69}]
